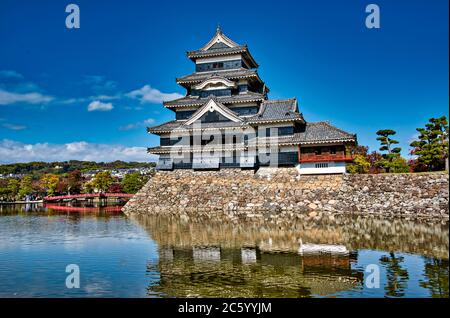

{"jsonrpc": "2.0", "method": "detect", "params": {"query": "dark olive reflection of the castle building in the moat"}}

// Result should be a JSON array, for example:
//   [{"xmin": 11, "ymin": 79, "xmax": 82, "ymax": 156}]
[{"xmin": 149, "ymin": 247, "xmax": 363, "ymax": 298}]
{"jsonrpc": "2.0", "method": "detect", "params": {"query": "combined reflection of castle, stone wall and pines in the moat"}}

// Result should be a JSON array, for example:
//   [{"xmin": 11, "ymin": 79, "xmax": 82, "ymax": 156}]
[{"xmin": 133, "ymin": 216, "xmax": 448, "ymax": 297}]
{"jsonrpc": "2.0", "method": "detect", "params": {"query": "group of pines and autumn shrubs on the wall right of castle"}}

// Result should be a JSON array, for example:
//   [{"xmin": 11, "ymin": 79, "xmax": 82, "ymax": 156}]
[{"xmin": 347, "ymin": 116, "xmax": 449, "ymax": 173}]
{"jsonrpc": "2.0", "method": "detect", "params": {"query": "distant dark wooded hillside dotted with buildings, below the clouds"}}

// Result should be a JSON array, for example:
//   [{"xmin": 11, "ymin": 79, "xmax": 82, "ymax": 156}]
[{"xmin": 0, "ymin": 160, "xmax": 155, "ymax": 175}]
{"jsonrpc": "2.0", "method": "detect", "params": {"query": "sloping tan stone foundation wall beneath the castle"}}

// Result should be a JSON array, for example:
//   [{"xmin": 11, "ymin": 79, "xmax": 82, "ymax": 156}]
[{"xmin": 123, "ymin": 168, "xmax": 449, "ymax": 220}]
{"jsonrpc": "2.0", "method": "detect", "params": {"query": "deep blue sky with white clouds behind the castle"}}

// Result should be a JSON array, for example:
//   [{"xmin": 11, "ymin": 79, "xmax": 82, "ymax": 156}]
[{"xmin": 0, "ymin": 0, "xmax": 449, "ymax": 162}]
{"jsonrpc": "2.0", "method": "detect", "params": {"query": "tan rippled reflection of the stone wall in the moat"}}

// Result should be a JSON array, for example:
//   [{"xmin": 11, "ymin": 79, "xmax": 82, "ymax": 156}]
[{"xmin": 132, "ymin": 215, "xmax": 449, "ymax": 259}]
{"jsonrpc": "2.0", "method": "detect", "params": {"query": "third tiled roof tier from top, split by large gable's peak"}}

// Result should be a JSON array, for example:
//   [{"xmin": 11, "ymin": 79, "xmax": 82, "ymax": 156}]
[{"xmin": 164, "ymin": 92, "xmax": 265, "ymax": 108}]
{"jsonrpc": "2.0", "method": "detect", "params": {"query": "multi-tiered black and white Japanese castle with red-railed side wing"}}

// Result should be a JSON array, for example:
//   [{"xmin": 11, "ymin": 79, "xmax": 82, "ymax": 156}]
[{"xmin": 147, "ymin": 28, "xmax": 356, "ymax": 174}]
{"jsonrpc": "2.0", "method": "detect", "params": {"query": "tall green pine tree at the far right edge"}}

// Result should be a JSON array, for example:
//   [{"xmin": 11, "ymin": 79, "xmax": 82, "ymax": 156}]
[{"xmin": 410, "ymin": 116, "xmax": 449, "ymax": 171}]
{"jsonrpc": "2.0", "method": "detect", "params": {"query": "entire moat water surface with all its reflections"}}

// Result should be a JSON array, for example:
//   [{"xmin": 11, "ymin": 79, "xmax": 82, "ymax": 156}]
[{"xmin": 0, "ymin": 206, "xmax": 449, "ymax": 298}]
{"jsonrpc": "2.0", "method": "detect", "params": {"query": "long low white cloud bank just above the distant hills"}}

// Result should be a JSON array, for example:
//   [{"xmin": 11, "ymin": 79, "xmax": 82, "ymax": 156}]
[{"xmin": 0, "ymin": 139, "xmax": 157, "ymax": 163}]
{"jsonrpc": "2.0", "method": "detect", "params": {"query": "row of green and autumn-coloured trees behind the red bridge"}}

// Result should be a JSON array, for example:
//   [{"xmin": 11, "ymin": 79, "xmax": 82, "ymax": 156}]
[{"xmin": 0, "ymin": 170, "xmax": 150, "ymax": 201}]
